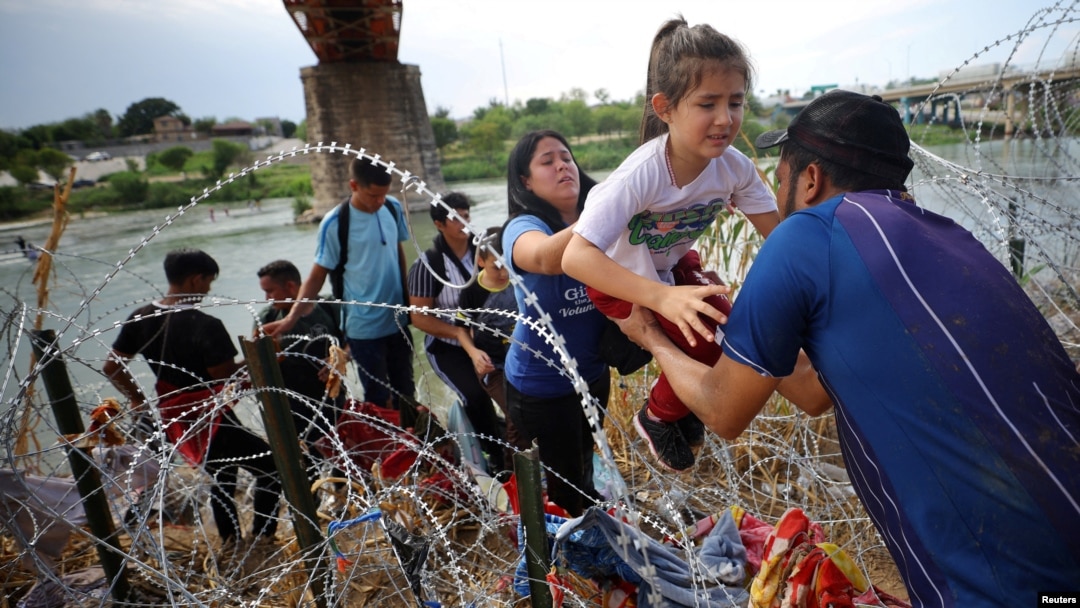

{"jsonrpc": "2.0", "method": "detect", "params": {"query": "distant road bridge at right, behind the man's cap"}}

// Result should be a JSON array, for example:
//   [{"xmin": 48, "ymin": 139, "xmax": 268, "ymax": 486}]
[{"xmin": 783, "ymin": 65, "xmax": 1080, "ymax": 137}]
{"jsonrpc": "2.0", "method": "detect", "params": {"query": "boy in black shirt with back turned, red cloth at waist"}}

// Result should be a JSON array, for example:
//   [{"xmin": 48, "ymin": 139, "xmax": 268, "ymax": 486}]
[{"xmin": 103, "ymin": 249, "xmax": 281, "ymax": 543}]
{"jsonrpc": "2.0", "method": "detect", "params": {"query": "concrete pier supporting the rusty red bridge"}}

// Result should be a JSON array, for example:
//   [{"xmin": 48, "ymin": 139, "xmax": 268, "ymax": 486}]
[{"xmin": 300, "ymin": 62, "xmax": 446, "ymax": 216}]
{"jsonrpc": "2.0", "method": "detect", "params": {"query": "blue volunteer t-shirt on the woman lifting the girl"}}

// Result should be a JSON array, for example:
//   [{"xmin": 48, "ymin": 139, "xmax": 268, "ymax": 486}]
[{"xmin": 502, "ymin": 215, "xmax": 607, "ymax": 397}]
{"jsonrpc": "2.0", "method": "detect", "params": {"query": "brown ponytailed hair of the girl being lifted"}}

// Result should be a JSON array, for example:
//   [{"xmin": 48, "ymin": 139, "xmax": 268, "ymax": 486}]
[{"xmin": 639, "ymin": 15, "xmax": 754, "ymax": 144}]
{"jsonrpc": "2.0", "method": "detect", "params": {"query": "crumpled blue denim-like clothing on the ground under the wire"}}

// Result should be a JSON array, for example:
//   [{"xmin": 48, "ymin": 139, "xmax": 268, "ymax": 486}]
[{"xmin": 514, "ymin": 506, "xmax": 750, "ymax": 608}]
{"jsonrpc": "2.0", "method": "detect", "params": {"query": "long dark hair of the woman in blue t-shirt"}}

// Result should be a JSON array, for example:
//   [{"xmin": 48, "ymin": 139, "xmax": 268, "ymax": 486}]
[{"xmin": 507, "ymin": 129, "xmax": 596, "ymax": 232}]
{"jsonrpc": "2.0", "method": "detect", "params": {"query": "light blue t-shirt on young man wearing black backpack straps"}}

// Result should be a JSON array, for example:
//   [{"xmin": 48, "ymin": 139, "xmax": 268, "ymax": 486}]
[{"xmin": 315, "ymin": 197, "xmax": 409, "ymax": 340}]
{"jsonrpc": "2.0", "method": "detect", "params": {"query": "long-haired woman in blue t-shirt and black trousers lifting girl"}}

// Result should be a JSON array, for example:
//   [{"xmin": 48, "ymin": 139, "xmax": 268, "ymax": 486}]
[{"xmin": 502, "ymin": 131, "xmax": 610, "ymax": 516}]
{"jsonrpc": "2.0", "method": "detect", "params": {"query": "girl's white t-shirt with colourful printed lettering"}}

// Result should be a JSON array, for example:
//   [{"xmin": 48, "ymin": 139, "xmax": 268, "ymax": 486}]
[{"xmin": 573, "ymin": 134, "xmax": 777, "ymax": 285}]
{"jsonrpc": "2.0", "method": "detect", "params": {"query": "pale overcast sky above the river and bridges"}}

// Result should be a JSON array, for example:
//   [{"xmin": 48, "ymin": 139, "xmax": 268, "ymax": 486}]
[{"xmin": 0, "ymin": 0, "xmax": 1080, "ymax": 130}]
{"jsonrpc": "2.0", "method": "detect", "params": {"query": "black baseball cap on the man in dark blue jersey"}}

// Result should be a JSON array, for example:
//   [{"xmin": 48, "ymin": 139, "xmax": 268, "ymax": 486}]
[{"xmin": 754, "ymin": 90, "xmax": 915, "ymax": 181}]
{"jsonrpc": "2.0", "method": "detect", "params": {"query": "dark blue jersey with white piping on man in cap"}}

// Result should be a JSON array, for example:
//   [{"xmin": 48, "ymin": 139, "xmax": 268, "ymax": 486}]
[{"xmin": 717, "ymin": 190, "xmax": 1080, "ymax": 608}]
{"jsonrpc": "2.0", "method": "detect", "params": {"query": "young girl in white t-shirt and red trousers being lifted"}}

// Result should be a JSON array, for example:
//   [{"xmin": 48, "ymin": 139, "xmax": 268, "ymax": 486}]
[{"xmin": 563, "ymin": 16, "xmax": 780, "ymax": 471}]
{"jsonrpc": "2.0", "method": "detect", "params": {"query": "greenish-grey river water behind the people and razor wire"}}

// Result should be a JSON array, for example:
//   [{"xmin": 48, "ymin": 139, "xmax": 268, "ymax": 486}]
[{"xmin": 0, "ymin": 140, "xmax": 1080, "ymax": 440}]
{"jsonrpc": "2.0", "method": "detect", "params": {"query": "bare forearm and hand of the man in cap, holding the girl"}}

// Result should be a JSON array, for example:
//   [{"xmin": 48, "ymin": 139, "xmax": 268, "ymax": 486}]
[{"xmin": 615, "ymin": 307, "xmax": 832, "ymax": 440}]
